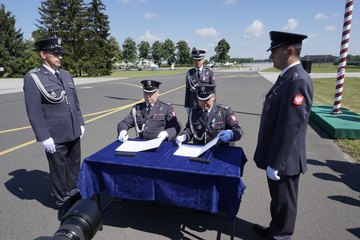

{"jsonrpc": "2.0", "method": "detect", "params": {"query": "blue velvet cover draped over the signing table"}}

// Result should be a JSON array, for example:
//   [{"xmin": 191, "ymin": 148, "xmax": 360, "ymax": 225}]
[{"xmin": 78, "ymin": 141, "xmax": 247, "ymax": 219}]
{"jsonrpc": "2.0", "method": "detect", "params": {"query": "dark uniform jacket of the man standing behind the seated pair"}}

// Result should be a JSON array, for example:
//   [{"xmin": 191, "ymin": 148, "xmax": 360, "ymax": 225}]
[{"xmin": 184, "ymin": 67, "xmax": 215, "ymax": 109}]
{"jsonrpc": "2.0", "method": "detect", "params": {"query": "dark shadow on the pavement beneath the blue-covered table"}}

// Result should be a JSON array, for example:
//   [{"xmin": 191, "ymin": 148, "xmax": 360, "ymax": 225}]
[{"xmin": 98, "ymin": 196, "xmax": 261, "ymax": 240}]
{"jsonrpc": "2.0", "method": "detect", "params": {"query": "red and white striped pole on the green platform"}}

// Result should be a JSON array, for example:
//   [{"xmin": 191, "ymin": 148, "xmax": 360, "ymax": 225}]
[{"xmin": 332, "ymin": 0, "xmax": 354, "ymax": 114}]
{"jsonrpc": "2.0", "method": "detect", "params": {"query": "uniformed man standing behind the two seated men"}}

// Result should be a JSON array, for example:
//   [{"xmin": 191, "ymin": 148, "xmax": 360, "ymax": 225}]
[{"xmin": 184, "ymin": 48, "xmax": 215, "ymax": 112}]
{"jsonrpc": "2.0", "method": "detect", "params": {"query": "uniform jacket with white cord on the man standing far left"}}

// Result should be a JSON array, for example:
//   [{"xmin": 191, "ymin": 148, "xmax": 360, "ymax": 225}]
[{"xmin": 23, "ymin": 66, "xmax": 84, "ymax": 143}]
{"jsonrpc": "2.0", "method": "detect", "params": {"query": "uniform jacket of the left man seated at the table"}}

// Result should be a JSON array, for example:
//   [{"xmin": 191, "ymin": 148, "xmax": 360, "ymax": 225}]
[{"xmin": 117, "ymin": 100, "xmax": 180, "ymax": 141}]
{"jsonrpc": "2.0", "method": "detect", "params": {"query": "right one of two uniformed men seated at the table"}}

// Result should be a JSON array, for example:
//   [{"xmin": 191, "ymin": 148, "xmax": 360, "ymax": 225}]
[{"xmin": 176, "ymin": 85, "xmax": 243, "ymax": 145}]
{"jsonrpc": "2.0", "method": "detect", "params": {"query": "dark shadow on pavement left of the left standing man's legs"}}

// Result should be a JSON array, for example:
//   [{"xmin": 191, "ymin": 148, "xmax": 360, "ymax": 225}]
[{"xmin": 4, "ymin": 169, "xmax": 57, "ymax": 209}]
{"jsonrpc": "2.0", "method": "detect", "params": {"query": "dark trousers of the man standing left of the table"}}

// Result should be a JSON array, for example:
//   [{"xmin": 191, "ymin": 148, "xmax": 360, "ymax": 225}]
[{"xmin": 46, "ymin": 138, "xmax": 81, "ymax": 206}]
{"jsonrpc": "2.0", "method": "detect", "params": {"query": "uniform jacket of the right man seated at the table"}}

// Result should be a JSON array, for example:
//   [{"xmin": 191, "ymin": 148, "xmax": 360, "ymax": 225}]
[{"xmin": 182, "ymin": 103, "xmax": 243, "ymax": 144}]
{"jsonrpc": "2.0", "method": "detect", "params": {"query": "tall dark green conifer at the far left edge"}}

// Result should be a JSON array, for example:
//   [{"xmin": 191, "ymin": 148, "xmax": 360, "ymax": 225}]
[{"xmin": 0, "ymin": 4, "xmax": 29, "ymax": 77}]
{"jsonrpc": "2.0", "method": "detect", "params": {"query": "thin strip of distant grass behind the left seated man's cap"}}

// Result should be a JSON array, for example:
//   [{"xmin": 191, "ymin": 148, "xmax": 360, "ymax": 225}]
[{"xmin": 103, "ymin": 69, "xmax": 188, "ymax": 78}]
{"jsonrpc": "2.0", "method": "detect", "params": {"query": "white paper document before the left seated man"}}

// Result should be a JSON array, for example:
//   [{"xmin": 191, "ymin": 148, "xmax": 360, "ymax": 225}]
[{"xmin": 115, "ymin": 138, "xmax": 164, "ymax": 152}]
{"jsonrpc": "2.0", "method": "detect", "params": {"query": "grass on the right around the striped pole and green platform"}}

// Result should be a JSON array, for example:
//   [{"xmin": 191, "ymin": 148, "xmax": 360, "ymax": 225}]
[{"xmin": 313, "ymin": 77, "xmax": 360, "ymax": 163}]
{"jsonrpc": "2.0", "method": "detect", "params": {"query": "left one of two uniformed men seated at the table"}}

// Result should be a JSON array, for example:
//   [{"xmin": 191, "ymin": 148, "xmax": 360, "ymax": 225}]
[{"xmin": 117, "ymin": 80, "xmax": 180, "ymax": 142}]
